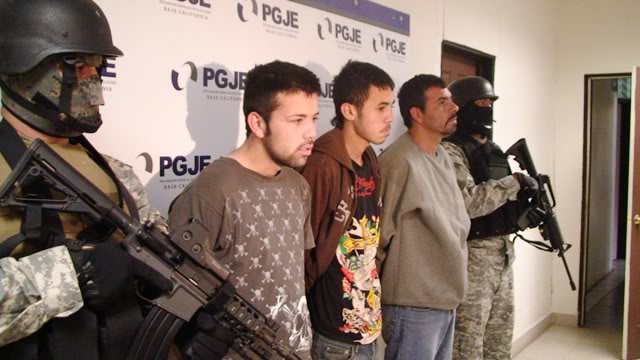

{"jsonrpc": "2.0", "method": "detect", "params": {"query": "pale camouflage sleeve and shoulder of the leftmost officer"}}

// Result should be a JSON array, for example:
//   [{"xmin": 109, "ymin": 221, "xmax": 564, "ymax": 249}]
[{"xmin": 0, "ymin": 135, "xmax": 160, "ymax": 346}]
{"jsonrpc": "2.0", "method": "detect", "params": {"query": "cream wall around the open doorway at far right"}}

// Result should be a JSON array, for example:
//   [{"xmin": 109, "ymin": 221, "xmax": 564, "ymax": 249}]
[{"xmin": 552, "ymin": 0, "xmax": 640, "ymax": 314}]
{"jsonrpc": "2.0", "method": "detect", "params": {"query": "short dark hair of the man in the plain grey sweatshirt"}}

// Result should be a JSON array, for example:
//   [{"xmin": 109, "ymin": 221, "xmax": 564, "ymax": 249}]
[{"xmin": 398, "ymin": 74, "xmax": 447, "ymax": 128}]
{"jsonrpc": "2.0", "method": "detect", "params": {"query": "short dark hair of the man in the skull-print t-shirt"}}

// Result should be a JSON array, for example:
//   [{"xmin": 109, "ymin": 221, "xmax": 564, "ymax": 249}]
[{"xmin": 242, "ymin": 60, "xmax": 320, "ymax": 137}]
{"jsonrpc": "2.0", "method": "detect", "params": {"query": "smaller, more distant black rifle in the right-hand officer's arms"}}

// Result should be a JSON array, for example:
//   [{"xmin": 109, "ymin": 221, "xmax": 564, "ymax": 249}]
[{"xmin": 506, "ymin": 139, "xmax": 576, "ymax": 291}]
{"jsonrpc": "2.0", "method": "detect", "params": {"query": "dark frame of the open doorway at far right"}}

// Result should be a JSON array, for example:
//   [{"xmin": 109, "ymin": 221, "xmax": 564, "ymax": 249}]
[{"xmin": 578, "ymin": 73, "xmax": 633, "ymax": 327}]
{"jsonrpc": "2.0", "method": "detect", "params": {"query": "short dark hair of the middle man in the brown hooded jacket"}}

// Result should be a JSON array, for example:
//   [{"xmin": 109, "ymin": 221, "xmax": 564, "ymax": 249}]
[{"xmin": 331, "ymin": 60, "xmax": 395, "ymax": 129}]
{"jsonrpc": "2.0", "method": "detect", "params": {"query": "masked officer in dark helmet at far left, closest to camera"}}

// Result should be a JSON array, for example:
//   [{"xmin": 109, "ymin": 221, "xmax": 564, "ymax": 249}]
[{"xmin": 0, "ymin": 0, "xmax": 172, "ymax": 359}]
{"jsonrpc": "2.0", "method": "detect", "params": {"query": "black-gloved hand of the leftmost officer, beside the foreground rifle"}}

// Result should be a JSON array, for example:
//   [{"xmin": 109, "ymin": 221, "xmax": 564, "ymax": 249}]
[{"xmin": 67, "ymin": 241, "xmax": 173, "ymax": 311}]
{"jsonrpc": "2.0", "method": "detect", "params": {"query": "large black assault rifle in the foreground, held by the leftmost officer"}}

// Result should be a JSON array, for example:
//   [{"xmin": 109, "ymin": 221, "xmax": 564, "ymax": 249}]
[{"xmin": 0, "ymin": 140, "xmax": 300, "ymax": 360}]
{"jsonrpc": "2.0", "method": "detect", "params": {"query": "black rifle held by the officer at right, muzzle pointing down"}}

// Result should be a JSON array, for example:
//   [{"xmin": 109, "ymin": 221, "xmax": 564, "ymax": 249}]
[{"xmin": 506, "ymin": 139, "xmax": 576, "ymax": 291}]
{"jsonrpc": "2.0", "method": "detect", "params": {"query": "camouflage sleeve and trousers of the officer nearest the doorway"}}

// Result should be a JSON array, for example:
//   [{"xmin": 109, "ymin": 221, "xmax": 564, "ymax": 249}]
[{"xmin": 443, "ymin": 142, "xmax": 520, "ymax": 360}]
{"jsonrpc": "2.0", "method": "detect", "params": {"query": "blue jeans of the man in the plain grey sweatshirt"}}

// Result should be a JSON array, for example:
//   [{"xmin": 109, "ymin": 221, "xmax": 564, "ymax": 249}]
[{"xmin": 382, "ymin": 305, "xmax": 456, "ymax": 360}]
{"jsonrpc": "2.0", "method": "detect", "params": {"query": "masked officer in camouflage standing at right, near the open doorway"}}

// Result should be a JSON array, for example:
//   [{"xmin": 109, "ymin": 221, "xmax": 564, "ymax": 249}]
[{"xmin": 443, "ymin": 76, "xmax": 537, "ymax": 360}]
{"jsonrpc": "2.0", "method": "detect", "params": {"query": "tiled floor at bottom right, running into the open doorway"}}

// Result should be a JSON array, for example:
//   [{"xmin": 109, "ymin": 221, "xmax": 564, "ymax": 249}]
[{"xmin": 515, "ymin": 262, "xmax": 624, "ymax": 360}]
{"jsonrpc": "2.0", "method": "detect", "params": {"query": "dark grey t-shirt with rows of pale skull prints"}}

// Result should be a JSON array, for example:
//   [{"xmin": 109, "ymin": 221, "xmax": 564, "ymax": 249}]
[{"xmin": 169, "ymin": 158, "xmax": 314, "ymax": 358}]
